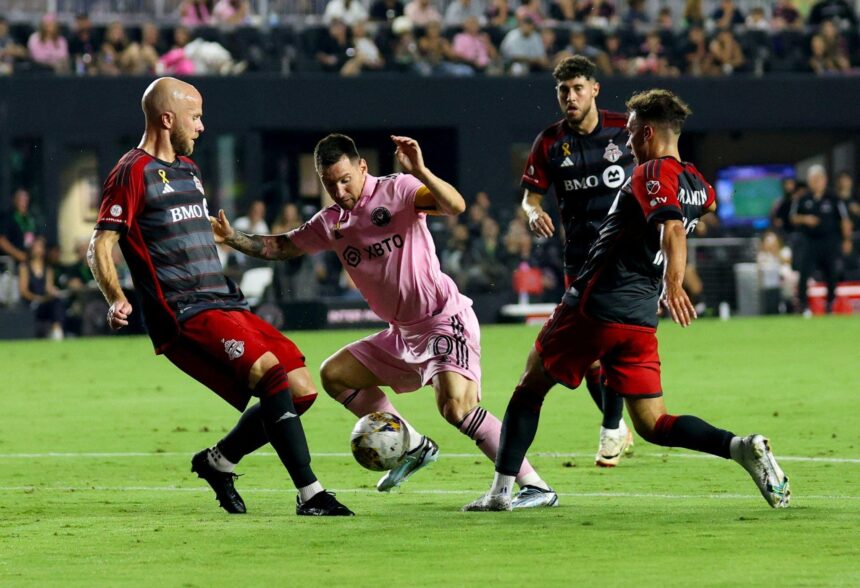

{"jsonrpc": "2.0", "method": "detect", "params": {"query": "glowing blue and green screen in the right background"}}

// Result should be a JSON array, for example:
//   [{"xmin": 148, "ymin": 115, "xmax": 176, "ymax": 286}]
[{"xmin": 714, "ymin": 164, "xmax": 795, "ymax": 229}]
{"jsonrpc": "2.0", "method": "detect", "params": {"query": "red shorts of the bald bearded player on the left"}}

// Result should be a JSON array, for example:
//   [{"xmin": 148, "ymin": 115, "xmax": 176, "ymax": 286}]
[{"xmin": 164, "ymin": 310, "xmax": 305, "ymax": 411}]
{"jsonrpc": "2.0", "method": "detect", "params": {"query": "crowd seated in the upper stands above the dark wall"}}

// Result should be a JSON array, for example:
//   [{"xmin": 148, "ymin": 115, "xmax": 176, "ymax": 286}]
[{"xmin": 5, "ymin": 0, "xmax": 860, "ymax": 76}]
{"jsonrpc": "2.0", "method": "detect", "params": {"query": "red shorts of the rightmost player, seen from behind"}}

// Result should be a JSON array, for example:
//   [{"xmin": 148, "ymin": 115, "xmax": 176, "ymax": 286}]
[{"xmin": 535, "ymin": 304, "xmax": 663, "ymax": 398}]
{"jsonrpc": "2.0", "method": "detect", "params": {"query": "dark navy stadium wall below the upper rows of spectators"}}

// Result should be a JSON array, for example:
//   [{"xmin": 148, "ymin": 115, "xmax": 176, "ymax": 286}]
[{"xmin": 0, "ymin": 75, "xmax": 860, "ymax": 243}]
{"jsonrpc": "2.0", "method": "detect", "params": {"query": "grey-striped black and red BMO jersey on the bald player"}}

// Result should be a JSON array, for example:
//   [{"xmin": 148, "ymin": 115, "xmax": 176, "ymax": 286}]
[{"xmin": 96, "ymin": 149, "xmax": 248, "ymax": 352}]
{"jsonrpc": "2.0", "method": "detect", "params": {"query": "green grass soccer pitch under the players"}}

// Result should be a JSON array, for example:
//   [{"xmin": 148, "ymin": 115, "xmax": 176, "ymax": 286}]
[{"xmin": 0, "ymin": 318, "xmax": 860, "ymax": 588}]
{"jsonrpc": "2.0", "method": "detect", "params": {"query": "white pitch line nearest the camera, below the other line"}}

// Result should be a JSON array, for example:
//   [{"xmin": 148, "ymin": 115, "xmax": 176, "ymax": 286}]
[{"xmin": 0, "ymin": 486, "xmax": 860, "ymax": 500}]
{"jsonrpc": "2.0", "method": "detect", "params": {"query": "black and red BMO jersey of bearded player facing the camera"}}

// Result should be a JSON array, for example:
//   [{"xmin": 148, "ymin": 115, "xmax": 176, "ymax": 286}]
[{"xmin": 521, "ymin": 110, "xmax": 634, "ymax": 277}]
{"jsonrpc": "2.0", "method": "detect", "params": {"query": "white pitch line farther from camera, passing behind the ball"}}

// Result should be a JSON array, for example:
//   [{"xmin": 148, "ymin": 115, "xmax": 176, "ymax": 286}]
[{"xmin": 0, "ymin": 451, "xmax": 860, "ymax": 464}]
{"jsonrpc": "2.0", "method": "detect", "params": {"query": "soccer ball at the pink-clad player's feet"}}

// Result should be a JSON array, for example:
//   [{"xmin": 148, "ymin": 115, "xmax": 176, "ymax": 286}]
[{"xmin": 350, "ymin": 412, "xmax": 409, "ymax": 472}]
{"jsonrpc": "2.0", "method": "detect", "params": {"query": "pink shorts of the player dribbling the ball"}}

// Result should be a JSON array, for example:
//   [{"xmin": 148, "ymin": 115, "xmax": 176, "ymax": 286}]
[{"xmin": 347, "ymin": 306, "xmax": 481, "ymax": 400}]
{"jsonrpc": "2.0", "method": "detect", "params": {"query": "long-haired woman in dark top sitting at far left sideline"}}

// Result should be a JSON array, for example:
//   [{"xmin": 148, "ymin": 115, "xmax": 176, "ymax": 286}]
[{"xmin": 18, "ymin": 235, "xmax": 65, "ymax": 339}]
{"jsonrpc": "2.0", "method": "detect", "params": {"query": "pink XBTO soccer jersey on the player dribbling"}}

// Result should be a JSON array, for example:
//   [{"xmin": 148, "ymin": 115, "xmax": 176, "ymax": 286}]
[{"xmin": 289, "ymin": 174, "xmax": 472, "ymax": 325}]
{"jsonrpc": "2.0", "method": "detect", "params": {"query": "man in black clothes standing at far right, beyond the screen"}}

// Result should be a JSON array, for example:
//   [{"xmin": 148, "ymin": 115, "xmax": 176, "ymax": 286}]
[{"xmin": 791, "ymin": 164, "xmax": 853, "ymax": 316}]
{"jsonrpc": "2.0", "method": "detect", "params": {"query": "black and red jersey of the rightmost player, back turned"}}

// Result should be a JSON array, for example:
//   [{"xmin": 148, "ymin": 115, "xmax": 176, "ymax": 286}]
[{"xmin": 564, "ymin": 157, "xmax": 715, "ymax": 327}]
